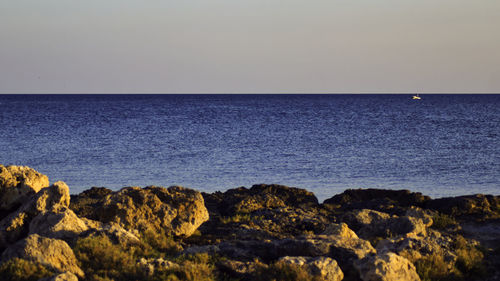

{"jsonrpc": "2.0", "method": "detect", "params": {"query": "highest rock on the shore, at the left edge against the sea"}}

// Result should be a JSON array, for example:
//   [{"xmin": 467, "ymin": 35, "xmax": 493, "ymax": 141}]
[{"xmin": 0, "ymin": 165, "xmax": 49, "ymax": 211}]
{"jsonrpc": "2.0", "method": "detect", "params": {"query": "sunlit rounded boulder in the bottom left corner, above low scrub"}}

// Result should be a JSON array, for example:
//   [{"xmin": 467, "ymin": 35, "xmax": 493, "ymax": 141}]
[{"xmin": 2, "ymin": 234, "xmax": 84, "ymax": 277}]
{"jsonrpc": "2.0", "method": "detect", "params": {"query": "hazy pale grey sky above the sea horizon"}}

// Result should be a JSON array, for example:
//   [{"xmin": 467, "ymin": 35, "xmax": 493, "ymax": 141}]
[{"xmin": 0, "ymin": 0, "xmax": 500, "ymax": 94}]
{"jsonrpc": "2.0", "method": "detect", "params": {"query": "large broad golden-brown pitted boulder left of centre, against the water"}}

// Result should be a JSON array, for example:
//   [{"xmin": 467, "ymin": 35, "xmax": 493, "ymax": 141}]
[{"xmin": 72, "ymin": 186, "xmax": 208, "ymax": 236}]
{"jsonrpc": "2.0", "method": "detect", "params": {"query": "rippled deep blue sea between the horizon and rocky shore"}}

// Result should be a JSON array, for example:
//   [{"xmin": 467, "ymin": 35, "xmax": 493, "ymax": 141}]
[{"xmin": 0, "ymin": 95, "xmax": 500, "ymax": 200}]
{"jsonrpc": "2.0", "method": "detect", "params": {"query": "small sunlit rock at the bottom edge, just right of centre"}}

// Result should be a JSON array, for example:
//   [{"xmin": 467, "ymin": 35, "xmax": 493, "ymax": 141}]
[{"xmin": 279, "ymin": 256, "xmax": 344, "ymax": 281}]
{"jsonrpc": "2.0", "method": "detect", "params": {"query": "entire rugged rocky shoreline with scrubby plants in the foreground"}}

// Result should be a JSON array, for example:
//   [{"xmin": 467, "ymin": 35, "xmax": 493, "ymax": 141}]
[{"xmin": 0, "ymin": 165, "xmax": 500, "ymax": 281}]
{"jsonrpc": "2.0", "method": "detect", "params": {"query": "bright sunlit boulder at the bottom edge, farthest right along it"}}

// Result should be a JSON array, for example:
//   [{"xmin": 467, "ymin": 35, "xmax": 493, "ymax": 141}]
[{"xmin": 354, "ymin": 252, "xmax": 420, "ymax": 281}]
